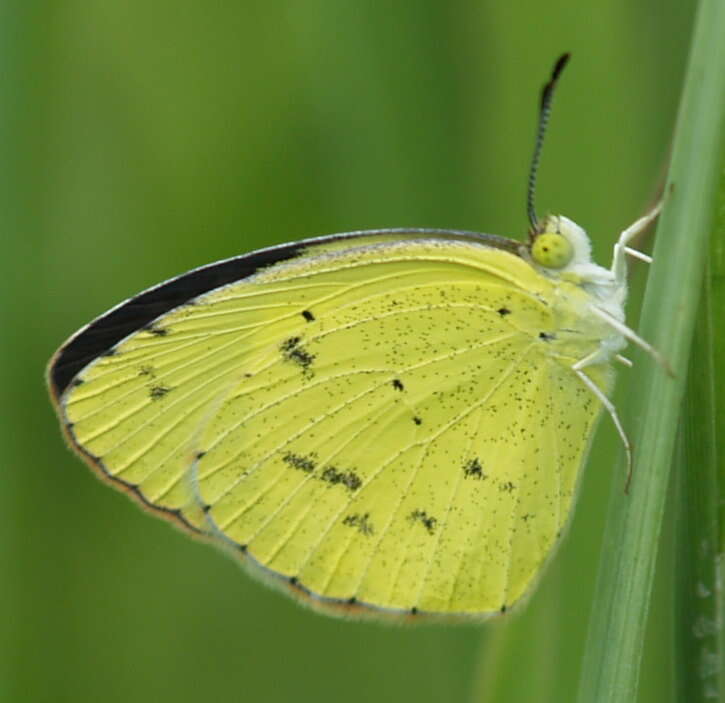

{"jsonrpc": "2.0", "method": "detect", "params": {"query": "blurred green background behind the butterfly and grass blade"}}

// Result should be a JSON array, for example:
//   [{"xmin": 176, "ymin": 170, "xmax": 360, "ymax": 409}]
[{"xmin": 0, "ymin": 0, "xmax": 694, "ymax": 703}]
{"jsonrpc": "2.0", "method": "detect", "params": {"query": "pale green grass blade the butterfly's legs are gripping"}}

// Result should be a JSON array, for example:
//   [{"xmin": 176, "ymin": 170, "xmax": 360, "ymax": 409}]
[{"xmin": 578, "ymin": 0, "xmax": 725, "ymax": 703}]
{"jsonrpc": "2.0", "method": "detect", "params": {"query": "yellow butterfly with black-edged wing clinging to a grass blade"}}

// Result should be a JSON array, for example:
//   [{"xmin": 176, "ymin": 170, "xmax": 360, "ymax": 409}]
[{"xmin": 48, "ymin": 56, "xmax": 658, "ymax": 618}]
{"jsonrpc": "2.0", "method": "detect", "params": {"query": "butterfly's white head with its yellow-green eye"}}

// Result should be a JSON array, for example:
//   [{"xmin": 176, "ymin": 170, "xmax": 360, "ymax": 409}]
[{"xmin": 529, "ymin": 215, "xmax": 592, "ymax": 273}]
